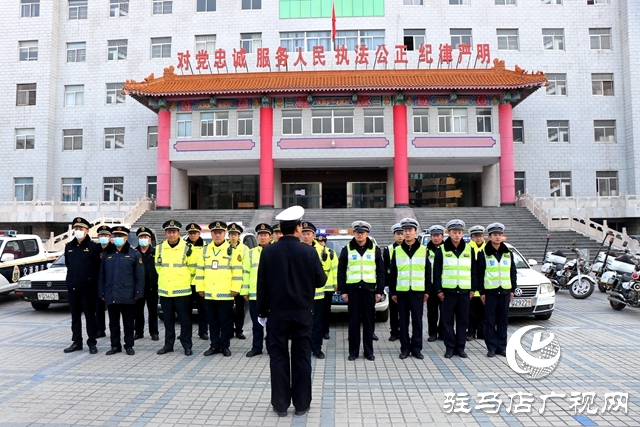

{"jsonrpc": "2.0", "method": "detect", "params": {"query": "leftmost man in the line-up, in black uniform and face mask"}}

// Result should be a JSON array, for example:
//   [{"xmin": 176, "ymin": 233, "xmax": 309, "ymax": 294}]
[{"xmin": 64, "ymin": 217, "xmax": 102, "ymax": 354}]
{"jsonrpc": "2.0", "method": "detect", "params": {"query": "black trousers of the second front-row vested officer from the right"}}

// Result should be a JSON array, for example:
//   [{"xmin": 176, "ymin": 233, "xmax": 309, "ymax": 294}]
[{"xmin": 441, "ymin": 291, "xmax": 471, "ymax": 353}]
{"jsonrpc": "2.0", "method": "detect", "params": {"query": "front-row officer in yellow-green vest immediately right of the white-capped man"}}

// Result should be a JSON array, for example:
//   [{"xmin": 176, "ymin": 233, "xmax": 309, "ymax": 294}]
[{"xmin": 338, "ymin": 221, "xmax": 385, "ymax": 360}]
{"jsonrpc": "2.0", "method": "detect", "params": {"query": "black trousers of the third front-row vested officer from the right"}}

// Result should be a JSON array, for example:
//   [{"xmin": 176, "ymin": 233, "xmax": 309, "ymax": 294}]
[{"xmin": 396, "ymin": 291, "xmax": 424, "ymax": 354}]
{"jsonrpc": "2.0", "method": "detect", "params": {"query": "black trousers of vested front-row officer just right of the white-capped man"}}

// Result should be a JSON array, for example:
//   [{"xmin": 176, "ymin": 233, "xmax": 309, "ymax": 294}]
[{"xmin": 347, "ymin": 286, "xmax": 376, "ymax": 356}]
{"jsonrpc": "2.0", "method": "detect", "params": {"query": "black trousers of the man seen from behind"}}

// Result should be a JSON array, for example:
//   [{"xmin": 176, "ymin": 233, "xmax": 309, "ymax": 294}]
[{"xmin": 267, "ymin": 310, "xmax": 313, "ymax": 412}]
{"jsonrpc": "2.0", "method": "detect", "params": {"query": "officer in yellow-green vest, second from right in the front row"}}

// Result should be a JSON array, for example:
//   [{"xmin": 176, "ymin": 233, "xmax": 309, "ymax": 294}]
[{"xmin": 433, "ymin": 219, "xmax": 476, "ymax": 359}]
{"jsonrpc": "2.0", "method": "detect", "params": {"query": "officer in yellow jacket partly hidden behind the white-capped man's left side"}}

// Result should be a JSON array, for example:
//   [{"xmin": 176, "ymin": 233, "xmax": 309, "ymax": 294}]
[{"xmin": 240, "ymin": 223, "xmax": 273, "ymax": 357}]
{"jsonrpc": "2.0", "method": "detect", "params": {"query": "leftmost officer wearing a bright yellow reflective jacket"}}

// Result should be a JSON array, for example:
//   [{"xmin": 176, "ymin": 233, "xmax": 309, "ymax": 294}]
[{"xmin": 155, "ymin": 219, "xmax": 193, "ymax": 356}]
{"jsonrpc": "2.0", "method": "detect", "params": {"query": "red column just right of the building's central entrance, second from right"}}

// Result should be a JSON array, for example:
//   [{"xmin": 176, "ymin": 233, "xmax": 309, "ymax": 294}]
[{"xmin": 393, "ymin": 104, "xmax": 409, "ymax": 207}]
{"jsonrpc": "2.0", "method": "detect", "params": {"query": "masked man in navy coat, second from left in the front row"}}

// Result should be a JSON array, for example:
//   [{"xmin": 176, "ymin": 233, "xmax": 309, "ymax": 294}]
[{"xmin": 98, "ymin": 226, "xmax": 144, "ymax": 356}]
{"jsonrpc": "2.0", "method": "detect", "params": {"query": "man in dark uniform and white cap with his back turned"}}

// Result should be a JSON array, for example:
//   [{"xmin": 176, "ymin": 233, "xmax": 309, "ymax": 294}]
[{"xmin": 257, "ymin": 206, "xmax": 327, "ymax": 417}]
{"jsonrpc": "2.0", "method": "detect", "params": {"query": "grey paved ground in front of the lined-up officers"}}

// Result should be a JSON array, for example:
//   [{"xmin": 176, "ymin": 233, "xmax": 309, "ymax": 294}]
[{"xmin": 0, "ymin": 290, "xmax": 640, "ymax": 427}]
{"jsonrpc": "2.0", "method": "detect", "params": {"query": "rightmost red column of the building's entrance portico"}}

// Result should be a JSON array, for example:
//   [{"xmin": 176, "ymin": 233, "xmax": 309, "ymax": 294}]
[{"xmin": 498, "ymin": 103, "xmax": 516, "ymax": 205}]
